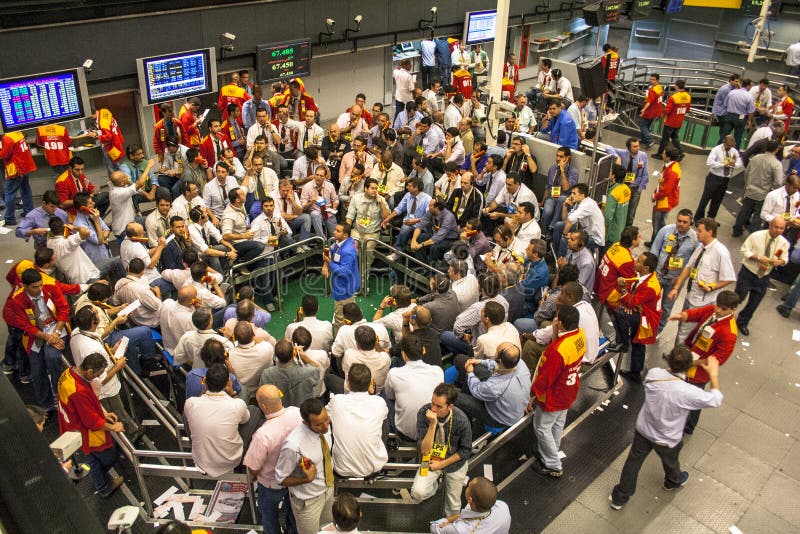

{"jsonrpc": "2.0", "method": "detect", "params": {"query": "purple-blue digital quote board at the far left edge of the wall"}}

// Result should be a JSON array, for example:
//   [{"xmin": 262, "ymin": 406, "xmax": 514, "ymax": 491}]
[{"xmin": 0, "ymin": 69, "xmax": 90, "ymax": 131}]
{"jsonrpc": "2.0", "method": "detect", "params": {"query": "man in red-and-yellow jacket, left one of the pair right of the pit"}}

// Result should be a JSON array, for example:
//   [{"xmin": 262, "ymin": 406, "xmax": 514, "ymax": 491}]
[{"xmin": 594, "ymin": 226, "xmax": 639, "ymax": 311}]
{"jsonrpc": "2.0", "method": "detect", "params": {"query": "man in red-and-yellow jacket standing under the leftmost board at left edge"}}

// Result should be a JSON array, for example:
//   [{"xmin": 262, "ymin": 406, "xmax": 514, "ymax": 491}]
[{"xmin": 0, "ymin": 132, "xmax": 36, "ymax": 226}]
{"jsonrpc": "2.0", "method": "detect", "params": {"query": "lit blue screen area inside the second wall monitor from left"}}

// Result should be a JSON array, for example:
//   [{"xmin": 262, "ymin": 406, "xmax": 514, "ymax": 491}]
[{"xmin": 145, "ymin": 52, "xmax": 209, "ymax": 102}]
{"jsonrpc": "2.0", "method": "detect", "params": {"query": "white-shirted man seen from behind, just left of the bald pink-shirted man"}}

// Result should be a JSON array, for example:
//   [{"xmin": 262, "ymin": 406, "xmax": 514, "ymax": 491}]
[{"xmin": 183, "ymin": 363, "xmax": 250, "ymax": 477}]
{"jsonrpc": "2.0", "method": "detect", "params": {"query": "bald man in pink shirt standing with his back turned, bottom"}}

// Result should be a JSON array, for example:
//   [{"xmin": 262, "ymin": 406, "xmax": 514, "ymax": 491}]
[{"xmin": 243, "ymin": 384, "xmax": 303, "ymax": 532}]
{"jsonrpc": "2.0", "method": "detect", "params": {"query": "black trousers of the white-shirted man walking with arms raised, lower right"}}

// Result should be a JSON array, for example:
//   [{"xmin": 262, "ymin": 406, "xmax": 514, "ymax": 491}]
[{"xmin": 611, "ymin": 430, "xmax": 683, "ymax": 504}]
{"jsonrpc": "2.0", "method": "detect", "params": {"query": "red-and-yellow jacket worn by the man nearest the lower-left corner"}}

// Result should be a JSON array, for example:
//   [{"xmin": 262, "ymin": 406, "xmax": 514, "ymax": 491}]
[{"xmin": 58, "ymin": 367, "xmax": 114, "ymax": 454}]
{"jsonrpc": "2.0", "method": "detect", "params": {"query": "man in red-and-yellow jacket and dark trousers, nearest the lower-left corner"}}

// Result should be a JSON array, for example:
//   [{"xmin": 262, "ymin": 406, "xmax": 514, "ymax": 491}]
[{"xmin": 58, "ymin": 353, "xmax": 125, "ymax": 498}]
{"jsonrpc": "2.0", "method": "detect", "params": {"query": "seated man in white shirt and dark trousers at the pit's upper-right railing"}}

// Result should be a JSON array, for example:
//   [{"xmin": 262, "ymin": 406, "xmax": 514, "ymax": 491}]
[{"xmin": 553, "ymin": 183, "xmax": 606, "ymax": 257}]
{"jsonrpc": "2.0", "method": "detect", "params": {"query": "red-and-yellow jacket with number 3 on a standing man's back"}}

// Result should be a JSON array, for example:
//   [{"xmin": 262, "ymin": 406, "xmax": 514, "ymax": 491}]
[{"xmin": 531, "ymin": 328, "xmax": 586, "ymax": 412}]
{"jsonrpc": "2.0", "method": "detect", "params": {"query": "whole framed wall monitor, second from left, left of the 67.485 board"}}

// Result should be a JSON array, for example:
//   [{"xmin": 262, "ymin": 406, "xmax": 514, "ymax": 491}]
[{"xmin": 136, "ymin": 47, "xmax": 217, "ymax": 104}]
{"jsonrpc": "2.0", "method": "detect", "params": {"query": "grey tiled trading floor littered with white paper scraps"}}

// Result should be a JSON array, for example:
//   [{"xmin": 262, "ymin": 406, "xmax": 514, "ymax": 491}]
[{"xmin": 0, "ymin": 127, "xmax": 800, "ymax": 534}]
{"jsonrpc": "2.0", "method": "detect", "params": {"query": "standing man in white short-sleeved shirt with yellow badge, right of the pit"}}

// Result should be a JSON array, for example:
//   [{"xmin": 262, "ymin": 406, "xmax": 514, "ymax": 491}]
[{"xmin": 667, "ymin": 218, "xmax": 736, "ymax": 343}]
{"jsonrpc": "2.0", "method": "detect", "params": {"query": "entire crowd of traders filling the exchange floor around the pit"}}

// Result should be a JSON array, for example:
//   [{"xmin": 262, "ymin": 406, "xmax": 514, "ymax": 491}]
[{"xmin": 0, "ymin": 42, "xmax": 800, "ymax": 534}]
